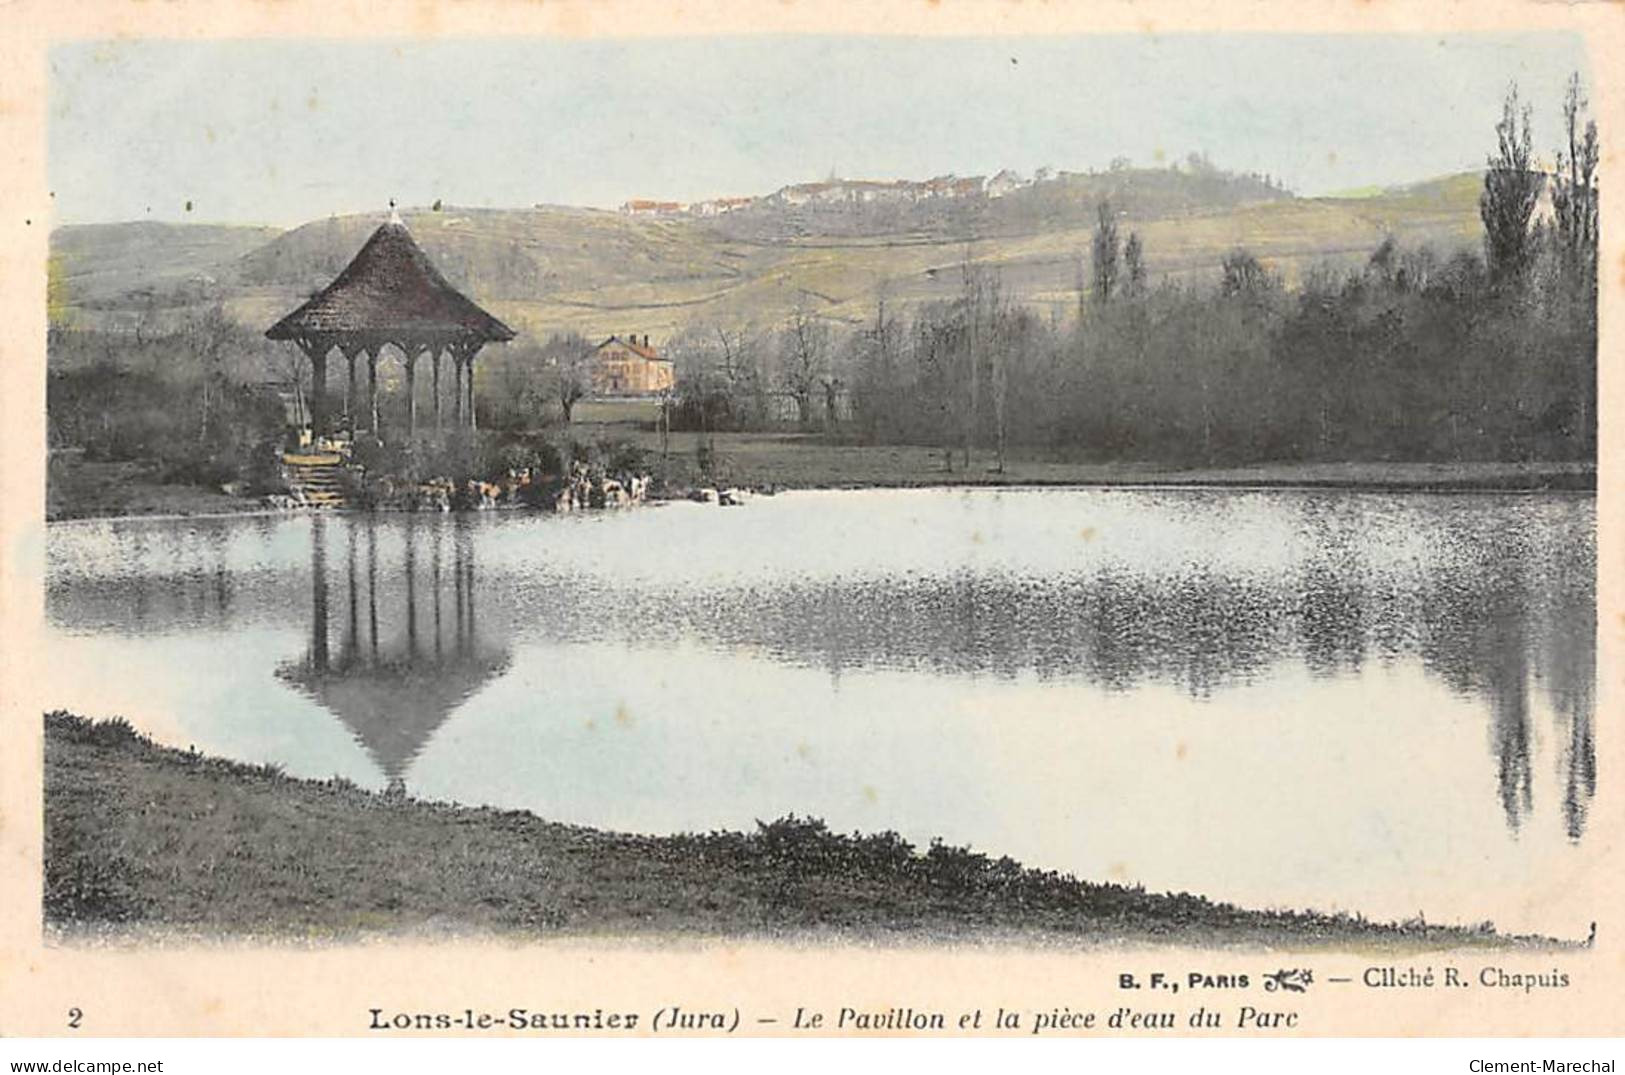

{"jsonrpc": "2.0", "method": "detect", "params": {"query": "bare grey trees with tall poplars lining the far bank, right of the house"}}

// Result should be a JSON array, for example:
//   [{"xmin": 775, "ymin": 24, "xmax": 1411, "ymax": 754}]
[{"xmin": 671, "ymin": 76, "xmax": 1599, "ymax": 469}]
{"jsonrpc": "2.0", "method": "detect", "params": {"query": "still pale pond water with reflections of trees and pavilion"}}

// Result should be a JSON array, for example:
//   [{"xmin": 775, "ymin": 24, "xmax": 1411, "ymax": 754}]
[{"xmin": 47, "ymin": 490, "xmax": 1597, "ymax": 934}]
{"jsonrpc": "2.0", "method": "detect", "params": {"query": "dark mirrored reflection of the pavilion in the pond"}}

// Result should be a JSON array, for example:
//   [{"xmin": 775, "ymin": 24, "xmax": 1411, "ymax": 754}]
[{"xmin": 276, "ymin": 515, "xmax": 510, "ymax": 792}]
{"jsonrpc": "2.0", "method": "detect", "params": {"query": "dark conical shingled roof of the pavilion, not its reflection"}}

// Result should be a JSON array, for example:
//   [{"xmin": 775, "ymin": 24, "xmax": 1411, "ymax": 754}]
[{"xmin": 265, "ymin": 218, "xmax": 514, "ymax": 343}]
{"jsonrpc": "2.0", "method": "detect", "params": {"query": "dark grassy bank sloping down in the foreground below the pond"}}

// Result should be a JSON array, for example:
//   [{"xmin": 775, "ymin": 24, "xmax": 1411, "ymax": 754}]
[{"xmin": 34, "ymin": 713, "xmax": 1552, "ymax": 948}]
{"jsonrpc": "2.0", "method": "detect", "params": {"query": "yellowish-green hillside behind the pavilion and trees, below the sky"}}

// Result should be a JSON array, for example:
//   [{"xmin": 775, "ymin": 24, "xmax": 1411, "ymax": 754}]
[{"xmin": 52, "ymin": 169, "xmax": 1479, "ymax": 347}]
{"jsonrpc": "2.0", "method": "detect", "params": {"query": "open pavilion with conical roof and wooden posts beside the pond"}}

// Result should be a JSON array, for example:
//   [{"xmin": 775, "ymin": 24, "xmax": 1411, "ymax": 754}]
[{"xmin": 265, "ymin": 213, "xmax": 514, "ymax": 440}]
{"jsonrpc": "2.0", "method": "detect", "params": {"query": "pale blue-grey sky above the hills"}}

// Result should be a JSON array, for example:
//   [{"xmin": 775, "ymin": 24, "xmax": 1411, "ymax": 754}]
[{"xmin": 49, "ymin": 34, "xmax": 1588, "ymax": 226}]
